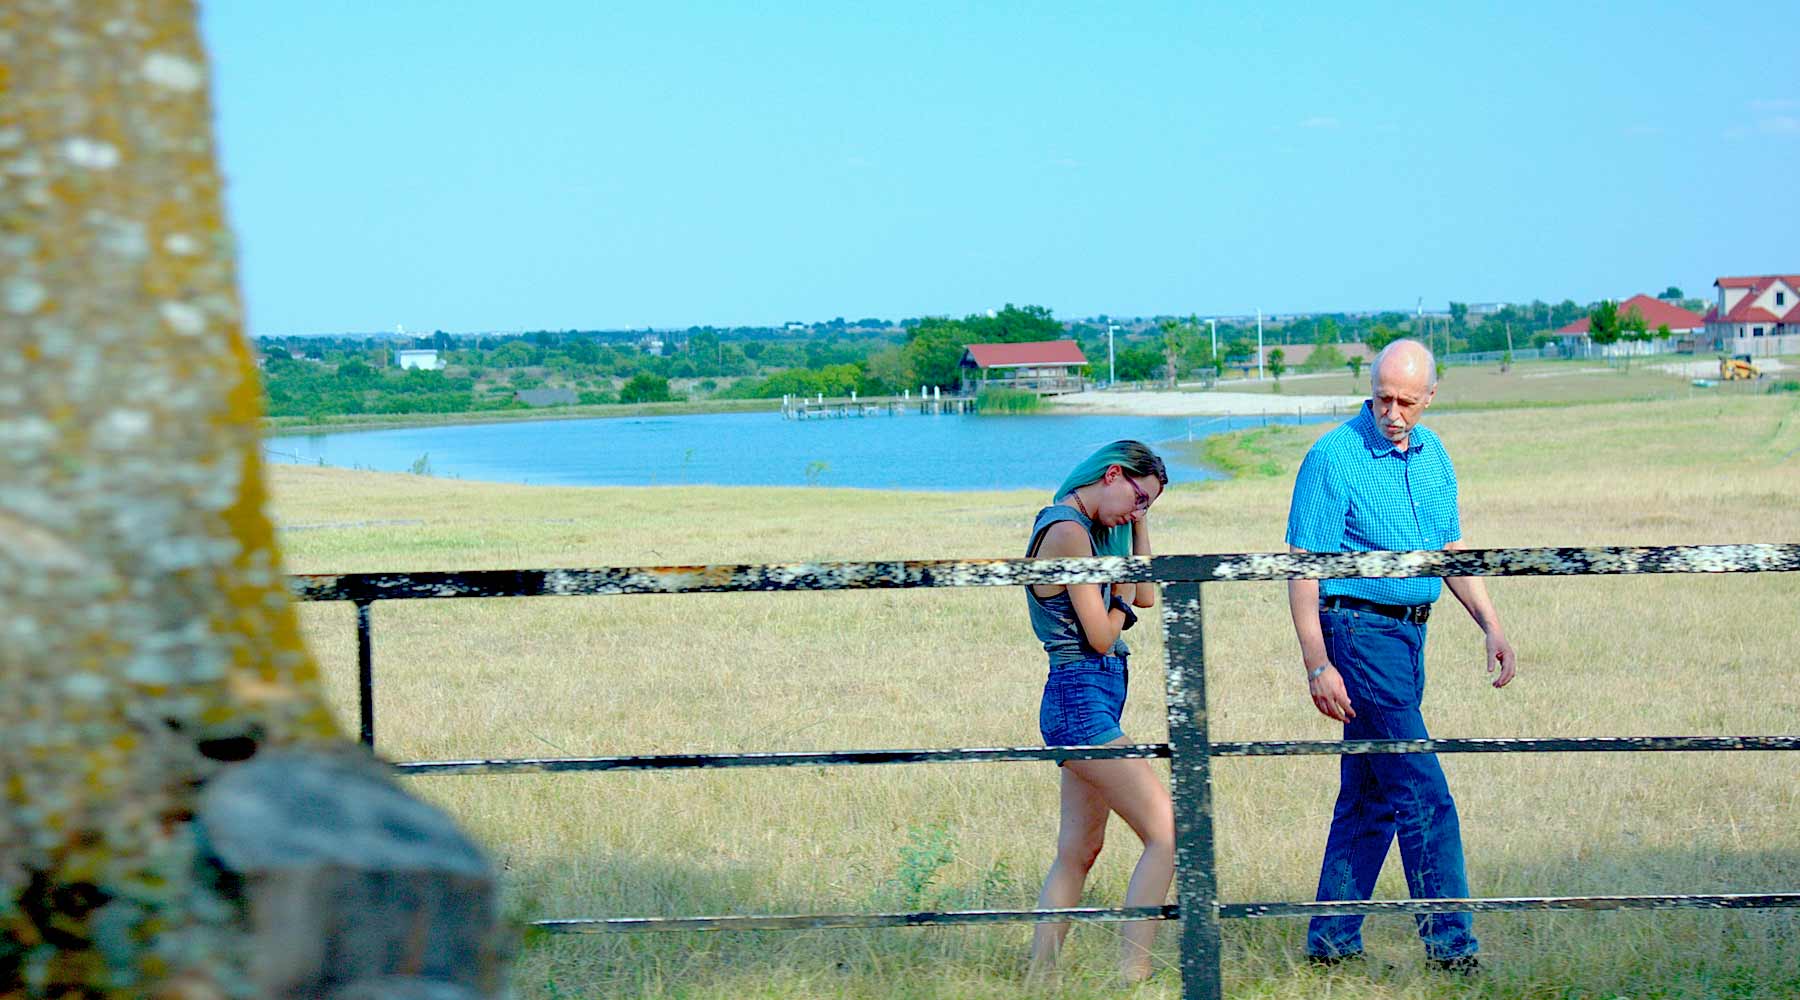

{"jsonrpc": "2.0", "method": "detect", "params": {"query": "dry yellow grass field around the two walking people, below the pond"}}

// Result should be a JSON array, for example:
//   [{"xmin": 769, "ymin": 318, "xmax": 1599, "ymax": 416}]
[{"xmin": 272, "ymin": 393, "xmax": 1800, "ymax": 1000}]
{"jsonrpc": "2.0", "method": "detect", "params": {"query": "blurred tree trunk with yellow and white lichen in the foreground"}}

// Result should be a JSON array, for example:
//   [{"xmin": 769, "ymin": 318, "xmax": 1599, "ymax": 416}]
[{"xmin": 0, "ymin": 0, "xmax": 491, "ymax": 996}]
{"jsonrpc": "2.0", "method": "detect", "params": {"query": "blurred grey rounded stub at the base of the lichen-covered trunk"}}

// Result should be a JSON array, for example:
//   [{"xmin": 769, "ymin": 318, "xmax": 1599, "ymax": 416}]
[{"xmin": 198, "ymin": 748, "xmax": 502, "ymax": 996}]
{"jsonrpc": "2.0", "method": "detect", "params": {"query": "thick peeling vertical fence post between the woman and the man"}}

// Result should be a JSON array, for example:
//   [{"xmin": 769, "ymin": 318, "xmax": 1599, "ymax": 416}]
[{"xmin": 1163, "ymin": 583, "xmax": 1224, "ymax": 1000}]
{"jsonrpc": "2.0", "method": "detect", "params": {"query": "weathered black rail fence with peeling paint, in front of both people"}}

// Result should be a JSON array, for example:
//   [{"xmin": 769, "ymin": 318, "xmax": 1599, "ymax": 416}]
[{"xmin": 292, "ymin": 545, "xmax": 1800, "ymax": 1000}]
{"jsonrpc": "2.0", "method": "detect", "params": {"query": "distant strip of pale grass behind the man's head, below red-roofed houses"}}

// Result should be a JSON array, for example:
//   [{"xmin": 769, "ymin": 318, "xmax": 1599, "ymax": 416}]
[{"xmin": 1195, "ymin": 354, "xmax": 1793, "ymax": 412}]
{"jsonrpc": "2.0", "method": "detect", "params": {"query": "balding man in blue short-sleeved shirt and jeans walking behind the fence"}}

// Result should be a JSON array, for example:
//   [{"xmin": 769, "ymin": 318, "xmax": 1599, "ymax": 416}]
[{"xmin": 1287, "ymin": 340, "xmax": 1517, "ymax": 973}]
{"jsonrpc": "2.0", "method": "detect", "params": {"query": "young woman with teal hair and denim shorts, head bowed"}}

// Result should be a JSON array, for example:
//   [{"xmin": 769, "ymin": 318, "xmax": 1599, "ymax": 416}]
[{"xmin": 1026, "ymin": 441, "xmax": 1175, "ymax": 982}]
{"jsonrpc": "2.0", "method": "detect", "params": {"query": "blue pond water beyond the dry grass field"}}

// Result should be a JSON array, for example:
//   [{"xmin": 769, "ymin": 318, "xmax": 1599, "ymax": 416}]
[{"xmin": 265, "ymin": 414, "xmax": 1332, "ymax": 491}]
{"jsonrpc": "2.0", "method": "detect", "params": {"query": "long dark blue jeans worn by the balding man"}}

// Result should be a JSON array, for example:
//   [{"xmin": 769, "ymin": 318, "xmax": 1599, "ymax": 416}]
[{"xmin": 1307, "ymin": 608, "xmax": 1478, "ymax": 959}]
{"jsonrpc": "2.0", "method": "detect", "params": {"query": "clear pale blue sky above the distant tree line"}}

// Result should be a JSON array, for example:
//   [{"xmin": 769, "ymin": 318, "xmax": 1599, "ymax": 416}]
[{"xmin": 203, "ymin": 0, "xmax": 1800, "ymax": 335}]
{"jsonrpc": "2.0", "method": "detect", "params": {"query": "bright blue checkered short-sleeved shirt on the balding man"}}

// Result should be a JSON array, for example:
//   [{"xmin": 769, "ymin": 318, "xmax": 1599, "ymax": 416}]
[{"xmin": 1287, "ymin": 403, "xmax": 1462, "ymax": 604}]
